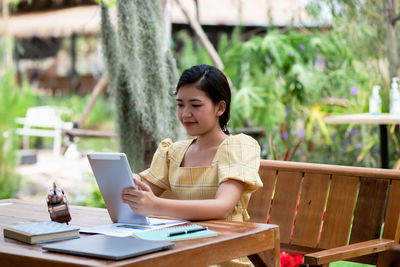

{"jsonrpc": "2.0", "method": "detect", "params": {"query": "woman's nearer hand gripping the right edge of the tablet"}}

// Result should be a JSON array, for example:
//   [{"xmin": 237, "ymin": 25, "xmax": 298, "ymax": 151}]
[{"xmin": 121, "ymin": 178, "xmax": 159, "ymax": 216}]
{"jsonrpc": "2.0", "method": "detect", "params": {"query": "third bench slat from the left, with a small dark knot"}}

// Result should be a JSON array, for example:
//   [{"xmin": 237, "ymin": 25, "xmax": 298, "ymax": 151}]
[{"xmin": 291, "ymin": 173, "xmax": 330, "ymax": 248}]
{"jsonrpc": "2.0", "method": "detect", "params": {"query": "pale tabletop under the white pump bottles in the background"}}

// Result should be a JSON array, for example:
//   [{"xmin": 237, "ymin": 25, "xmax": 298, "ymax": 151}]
[{"xmin": 324, "ymin": 113, "xmax": 400, "ymax": 124}]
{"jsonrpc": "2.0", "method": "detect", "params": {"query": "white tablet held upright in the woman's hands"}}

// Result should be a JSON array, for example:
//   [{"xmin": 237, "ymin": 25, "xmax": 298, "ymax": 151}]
[{"xmin": 87, "ymin": 152, "xmax": 149, "ymax": 224}]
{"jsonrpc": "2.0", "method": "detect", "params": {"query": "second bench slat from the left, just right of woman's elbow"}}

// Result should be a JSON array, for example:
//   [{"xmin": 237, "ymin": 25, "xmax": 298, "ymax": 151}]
[{"xmin": 269, "ymin": 171, "xmax": 303, "ymax": 243}]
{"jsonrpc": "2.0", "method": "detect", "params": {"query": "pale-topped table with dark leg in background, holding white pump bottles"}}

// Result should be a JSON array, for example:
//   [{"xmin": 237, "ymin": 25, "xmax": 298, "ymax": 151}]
[{"xmin": 325, "ymin": 113, "xmax": 400, "ymax": 169}]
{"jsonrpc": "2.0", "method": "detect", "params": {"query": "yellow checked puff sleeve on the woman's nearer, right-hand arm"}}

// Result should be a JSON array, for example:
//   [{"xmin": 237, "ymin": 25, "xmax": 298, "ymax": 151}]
[{"xmin": 218, "ymin": 134, "xmax": 263, "ymax": 193}]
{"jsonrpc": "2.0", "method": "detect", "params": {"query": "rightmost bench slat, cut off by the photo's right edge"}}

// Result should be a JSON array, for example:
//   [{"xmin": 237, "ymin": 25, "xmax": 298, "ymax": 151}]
[{"xmin": 382, "ymin": 180, "xmax": 400, "ymax": 244}]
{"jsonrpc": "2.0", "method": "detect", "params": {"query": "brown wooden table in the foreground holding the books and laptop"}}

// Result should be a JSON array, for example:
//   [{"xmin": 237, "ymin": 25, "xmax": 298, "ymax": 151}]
[{"xmin": 0, "ymin": 199, "xmax": 280, "ymax": 267}]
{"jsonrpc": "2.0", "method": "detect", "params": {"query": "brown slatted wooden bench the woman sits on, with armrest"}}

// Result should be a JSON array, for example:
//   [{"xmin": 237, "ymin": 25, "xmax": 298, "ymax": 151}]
[{"xmin": 248, "ymin": 160, "xmax": 400, "ymax": 266}]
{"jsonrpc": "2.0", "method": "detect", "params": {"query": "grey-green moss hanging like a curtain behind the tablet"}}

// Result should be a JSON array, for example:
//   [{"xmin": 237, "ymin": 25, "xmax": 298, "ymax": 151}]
[{"xmin": 101, "ymin": 0, "xmax": 182, "ymax": 171}]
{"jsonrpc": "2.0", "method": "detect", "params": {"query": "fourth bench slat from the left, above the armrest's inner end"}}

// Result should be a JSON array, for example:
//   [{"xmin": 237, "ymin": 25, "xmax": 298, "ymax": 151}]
[{"xmin": 318, "ymin": 175, "xmax": 359, "ymax": 249}]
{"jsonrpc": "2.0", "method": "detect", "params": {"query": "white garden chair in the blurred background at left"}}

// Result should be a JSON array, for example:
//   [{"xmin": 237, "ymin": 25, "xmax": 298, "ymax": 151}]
[{"xmin": 15, "ymin": 106, "xmax": 73, "ymax": 155}]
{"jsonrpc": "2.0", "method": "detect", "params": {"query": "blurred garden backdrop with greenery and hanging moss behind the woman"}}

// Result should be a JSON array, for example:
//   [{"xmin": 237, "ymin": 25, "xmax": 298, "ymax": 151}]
[{"xmin": 0, "ymin": 0, "xmax": 400, "ymax": 266}]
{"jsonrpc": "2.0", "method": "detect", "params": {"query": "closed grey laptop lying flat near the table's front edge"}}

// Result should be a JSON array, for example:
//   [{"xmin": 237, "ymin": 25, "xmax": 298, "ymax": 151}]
[{"xmin": 42, "ymin": 235, "xmax": 174, "ymax": 260}]
